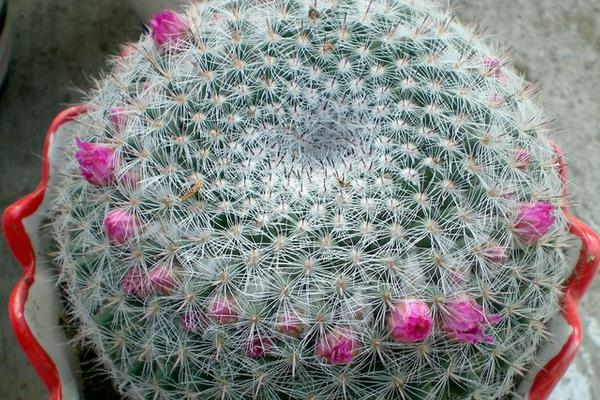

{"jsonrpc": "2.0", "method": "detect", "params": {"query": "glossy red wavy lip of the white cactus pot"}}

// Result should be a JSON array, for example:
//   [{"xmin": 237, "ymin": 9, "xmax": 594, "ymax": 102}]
[{"xmin": 2, "ymin": 105, "xmax": 600, "ymax": 400}]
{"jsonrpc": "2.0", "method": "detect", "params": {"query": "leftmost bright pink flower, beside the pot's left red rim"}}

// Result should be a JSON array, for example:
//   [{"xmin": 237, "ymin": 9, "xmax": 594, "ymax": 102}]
[{"xmin": 75, "ymin": 139, "xmax": 115, "ymax": 186}]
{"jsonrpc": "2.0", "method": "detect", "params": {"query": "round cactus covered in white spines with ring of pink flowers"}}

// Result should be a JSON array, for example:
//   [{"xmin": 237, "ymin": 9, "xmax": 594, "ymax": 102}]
[{"xmin": 52, "ymin": 0, "xmax": 570, "ymax": 400}]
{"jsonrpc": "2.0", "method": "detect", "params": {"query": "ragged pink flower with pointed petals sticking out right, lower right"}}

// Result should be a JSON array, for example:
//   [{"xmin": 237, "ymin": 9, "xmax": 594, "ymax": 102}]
[{"xmin": 443, "ymin": 298, "xmax": 501, "ymax": 343}]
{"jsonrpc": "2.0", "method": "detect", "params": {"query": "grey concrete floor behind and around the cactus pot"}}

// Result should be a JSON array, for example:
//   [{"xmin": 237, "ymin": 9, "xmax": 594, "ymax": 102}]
[{"xmin": 0, "ymin": 0, "xmax": 600, "ymax": 400}]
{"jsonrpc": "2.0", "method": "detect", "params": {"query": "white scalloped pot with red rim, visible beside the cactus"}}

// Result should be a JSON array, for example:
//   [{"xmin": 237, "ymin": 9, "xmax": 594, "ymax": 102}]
[{"xmin": 2, "ymin": 105, "xmax": 600, "ymax": 400}]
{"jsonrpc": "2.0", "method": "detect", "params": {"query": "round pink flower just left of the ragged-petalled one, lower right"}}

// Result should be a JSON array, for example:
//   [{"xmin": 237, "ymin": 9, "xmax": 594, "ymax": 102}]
[{"xmin": 387, "ymin": 299, "xmax": 433, "ymax": 343}]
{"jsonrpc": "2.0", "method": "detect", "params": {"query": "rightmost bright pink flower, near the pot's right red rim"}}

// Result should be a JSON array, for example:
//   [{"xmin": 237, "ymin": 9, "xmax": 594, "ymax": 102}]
[{"xmin": 513, "ymin": 201, "xmax": 556, "ymax": 244}]
